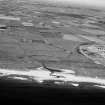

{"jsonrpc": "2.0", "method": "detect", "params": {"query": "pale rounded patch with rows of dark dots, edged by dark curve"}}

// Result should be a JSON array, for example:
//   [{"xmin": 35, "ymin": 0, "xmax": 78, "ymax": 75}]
[{"xmin": 79, "ymin": 44, "xmax": 105, "ymax": 64}]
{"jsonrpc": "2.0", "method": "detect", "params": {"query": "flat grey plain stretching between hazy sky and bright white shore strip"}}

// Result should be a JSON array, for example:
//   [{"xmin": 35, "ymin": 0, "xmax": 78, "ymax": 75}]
[{"xmin": 0, "ymin": 0, "xmax": 105, "ymax": 78}]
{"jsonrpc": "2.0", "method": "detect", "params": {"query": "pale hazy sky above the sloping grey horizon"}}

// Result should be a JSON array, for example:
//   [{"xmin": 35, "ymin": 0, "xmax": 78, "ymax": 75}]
[{"xmin": 37, "ymin": 0, "xmax": 105, "ymax": 9}]
